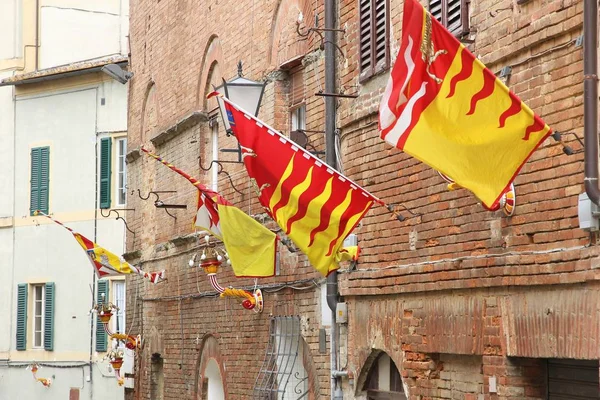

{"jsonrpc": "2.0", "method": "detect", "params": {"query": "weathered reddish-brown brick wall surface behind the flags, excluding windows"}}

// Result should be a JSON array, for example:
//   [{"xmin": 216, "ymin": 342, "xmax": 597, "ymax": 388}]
[{"xmin": 127, "ymin": 0, "xmax": 598, "ymax": 400}]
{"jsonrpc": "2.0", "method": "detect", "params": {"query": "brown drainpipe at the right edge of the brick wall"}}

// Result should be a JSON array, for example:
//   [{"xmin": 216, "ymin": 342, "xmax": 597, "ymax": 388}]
[{"xmin": 583, "ymin": 0, "xmax": 600, "ymax": 205}]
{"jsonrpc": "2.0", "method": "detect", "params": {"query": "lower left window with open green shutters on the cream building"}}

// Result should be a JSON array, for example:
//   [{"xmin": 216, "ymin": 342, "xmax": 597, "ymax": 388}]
[{"xmin": 16, "ymin": 282, "xmax": 55, "ymax": 351}]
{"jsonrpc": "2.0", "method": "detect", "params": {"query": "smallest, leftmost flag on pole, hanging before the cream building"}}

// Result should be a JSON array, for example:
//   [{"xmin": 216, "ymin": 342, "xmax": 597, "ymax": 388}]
[{"xmin": 36, "ymin": 211, "xmax": 165, "ymax": 283}]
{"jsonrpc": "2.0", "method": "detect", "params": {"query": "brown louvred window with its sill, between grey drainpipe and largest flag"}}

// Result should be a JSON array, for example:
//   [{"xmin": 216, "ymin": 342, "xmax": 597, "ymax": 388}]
[{"xmin": 358, "ymin": 0, "xmax": 391, "ymax": 83}]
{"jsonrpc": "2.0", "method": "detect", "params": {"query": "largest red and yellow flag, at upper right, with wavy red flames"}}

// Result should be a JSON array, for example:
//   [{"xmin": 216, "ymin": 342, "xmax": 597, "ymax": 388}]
[{"xmin": 379, "ymin": 0, "xmax": 551, "ymax": 209}]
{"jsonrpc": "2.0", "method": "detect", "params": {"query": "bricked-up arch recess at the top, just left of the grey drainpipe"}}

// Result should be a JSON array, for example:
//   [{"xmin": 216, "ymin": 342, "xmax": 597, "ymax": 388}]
[{"xmin": 267, "ymin": 0, "xmax": 315, "ymax": 68}]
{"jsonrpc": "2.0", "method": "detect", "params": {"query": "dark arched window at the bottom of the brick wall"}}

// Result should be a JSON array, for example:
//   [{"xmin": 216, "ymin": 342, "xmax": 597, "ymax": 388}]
[{"xmin": 363, "ymin": 352, "xmax": 406, "ymax": 400}]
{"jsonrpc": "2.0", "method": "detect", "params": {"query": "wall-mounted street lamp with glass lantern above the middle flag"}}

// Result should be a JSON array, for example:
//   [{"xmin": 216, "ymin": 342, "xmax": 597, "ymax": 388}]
[{"xmin": 215, "ymin": 61, "xmax": 266, "ymax": 135}]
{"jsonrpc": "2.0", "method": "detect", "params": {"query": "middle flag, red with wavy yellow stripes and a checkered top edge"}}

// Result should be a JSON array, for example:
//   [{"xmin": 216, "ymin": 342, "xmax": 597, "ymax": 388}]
[{"xmin": 223, "ymin": 99, "xmax": 379, "ymax": 275}]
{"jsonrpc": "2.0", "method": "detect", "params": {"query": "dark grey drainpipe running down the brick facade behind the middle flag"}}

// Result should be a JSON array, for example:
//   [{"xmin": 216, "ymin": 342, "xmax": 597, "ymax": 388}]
[{"xmin": 325, "ymin": 0, "xmax": 343, "ymax": 400}]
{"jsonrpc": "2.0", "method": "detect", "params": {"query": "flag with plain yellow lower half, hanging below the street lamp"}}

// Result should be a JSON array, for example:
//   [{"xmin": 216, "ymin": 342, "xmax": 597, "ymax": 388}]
[{"xmin": 142, "ymin": 148, "xmax": 277, "ymax": 278}]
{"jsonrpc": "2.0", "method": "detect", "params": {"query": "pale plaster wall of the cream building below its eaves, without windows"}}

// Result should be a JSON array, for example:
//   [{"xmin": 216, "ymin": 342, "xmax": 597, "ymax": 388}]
[{"xmin": 0, "ymin": 81, "xmax": 126, "ymax": 400}]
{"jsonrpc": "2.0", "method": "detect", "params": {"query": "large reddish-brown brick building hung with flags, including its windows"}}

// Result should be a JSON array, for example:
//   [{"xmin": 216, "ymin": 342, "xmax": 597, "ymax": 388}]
[{"xmin": 126, "ymin": 0, "xmax": 600, "ymax": 399}]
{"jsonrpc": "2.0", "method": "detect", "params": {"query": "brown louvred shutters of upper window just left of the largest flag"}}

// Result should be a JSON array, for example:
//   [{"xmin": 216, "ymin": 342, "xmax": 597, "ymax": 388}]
[{"xmin": 358, "ymin": 0, "xmax": 390, "ymax": 80}]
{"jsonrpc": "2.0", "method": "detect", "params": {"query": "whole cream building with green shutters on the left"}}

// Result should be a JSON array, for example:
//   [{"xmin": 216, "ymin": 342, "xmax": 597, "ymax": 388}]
[{"xmin": 0, "ymin": 0, "xmax": 132, "ymax": 400}]
